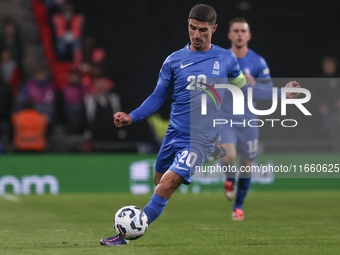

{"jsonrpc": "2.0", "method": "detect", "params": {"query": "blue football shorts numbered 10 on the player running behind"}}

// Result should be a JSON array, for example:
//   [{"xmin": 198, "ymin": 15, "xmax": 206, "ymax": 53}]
[{"xmin": 219, "ymin": 124, "xmax": 259, "ymax": 160}]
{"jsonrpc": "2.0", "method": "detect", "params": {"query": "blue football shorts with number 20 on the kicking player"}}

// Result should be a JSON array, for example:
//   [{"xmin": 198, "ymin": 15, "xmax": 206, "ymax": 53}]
[{"xmin": 155, "ymin": 125, "xmax": 215, "ymax": 184}]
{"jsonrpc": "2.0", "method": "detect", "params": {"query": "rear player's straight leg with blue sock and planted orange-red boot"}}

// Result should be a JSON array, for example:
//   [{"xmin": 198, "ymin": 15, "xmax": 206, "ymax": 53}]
[{"xmin": 232, "ymin": 157, "xmax": 252, "ymax": 220}]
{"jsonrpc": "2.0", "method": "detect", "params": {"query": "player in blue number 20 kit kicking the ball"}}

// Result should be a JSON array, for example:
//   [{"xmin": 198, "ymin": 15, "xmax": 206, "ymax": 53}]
[{"xmin": 100, "ymin": 4, "xmax": 299, "ymax": 246}]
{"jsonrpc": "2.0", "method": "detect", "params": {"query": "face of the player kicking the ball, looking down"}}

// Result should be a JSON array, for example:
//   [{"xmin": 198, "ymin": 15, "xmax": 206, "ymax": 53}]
[{"xmin": 188, "ymin": 19, "xmax": 217, "ymax": 51}]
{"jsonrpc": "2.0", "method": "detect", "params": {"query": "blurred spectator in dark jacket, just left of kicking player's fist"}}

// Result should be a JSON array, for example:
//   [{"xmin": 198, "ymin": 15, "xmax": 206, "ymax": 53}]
[{"xmin": 85, "ymin": 78, "xmax": 126, "ymax": 142}]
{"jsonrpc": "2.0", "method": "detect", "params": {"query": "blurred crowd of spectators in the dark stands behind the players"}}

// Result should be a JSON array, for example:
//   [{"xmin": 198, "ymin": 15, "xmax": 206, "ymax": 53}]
[{"xmin": 0, "ymin": 0, "xmax": 340, "ymax": 153}]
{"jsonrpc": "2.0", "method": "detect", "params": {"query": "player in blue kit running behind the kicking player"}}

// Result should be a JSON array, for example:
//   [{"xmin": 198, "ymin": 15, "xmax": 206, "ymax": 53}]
[{"xmin": 220, "ymin": 18, "xmax": 273, "ymax": 220}]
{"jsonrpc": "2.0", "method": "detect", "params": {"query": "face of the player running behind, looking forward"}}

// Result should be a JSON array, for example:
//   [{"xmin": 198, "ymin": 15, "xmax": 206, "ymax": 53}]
[{"xmin": 228, "ymin": 22, "xmax": 251, "ymax": 48}]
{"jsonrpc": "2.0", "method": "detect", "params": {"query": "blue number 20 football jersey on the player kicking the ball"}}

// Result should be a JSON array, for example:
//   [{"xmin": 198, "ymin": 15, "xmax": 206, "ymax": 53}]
[{"xmin": 157, "ymin": 44, "xmax": 246, "ymax": 141}]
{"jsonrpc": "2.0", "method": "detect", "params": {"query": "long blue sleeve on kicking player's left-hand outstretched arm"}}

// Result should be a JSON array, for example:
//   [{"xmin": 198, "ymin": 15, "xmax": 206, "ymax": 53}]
[{"xmin": 129, "ymin": 60, "xmax": 173, "ymax": 122}]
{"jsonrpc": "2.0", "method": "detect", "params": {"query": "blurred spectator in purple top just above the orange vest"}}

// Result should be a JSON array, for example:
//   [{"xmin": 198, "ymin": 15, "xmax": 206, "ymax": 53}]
[{"xmin": 19, "ymin": 68, "xmax": 55, "ymax": 124}]
